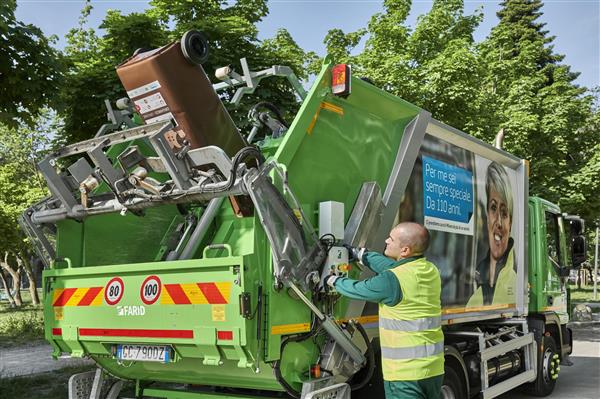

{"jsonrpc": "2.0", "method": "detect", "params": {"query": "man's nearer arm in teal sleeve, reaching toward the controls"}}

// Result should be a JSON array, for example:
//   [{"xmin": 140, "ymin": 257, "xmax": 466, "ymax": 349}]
[{"xmin": 333, "ymin": 272, "xmax": 402, "ymax": 306}]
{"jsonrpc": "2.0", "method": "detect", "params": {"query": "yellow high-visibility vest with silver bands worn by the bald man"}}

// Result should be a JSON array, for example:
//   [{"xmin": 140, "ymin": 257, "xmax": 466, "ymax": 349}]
[{"xmin": 379, "ymin": 258, "xmax": 444, "ymax": 381}]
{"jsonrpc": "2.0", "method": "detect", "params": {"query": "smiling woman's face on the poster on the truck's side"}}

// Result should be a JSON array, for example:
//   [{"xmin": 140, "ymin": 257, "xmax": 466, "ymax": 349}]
[{"xmin": 487, "ymin": 188, "xmax": 511, "ymax": 260}]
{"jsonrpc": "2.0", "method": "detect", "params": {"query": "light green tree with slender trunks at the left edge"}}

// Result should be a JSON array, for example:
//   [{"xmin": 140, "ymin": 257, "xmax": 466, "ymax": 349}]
[{"xmin": 0, "ymin": 110, "xmax": 56, "ymax": 306}]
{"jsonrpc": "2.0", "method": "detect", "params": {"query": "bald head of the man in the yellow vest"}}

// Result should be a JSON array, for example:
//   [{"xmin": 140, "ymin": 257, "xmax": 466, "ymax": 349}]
[{"xmin": 385, "ymin": 222, "xmax": 429, "ymax": 259}]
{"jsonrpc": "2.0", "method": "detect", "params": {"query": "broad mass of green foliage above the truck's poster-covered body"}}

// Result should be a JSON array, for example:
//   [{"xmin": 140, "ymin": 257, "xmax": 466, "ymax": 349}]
[{"xmin": 318, "ymin": 0, "xmax": 600, "ymax": 220}]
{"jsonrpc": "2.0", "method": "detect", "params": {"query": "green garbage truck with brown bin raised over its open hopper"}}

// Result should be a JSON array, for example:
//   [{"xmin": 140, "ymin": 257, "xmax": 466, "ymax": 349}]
[{"xmin": 20, "ymin": 31, "xmax": 585, "ymax": 399}]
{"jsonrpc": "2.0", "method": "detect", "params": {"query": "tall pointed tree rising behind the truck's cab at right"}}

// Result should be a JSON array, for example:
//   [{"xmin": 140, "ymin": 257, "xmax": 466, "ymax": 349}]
[{"xmin": 471, "ymin": 0, "xmax": 598, "ymax": 212}]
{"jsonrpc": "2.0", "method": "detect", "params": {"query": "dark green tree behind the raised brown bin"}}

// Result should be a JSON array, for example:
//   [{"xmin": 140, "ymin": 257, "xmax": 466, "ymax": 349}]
[{"xmin": 60, "ymin": 0, "xmax": 312, "ymax": 142}]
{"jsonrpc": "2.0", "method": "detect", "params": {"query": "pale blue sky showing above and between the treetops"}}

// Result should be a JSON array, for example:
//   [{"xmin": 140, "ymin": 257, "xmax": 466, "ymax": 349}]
[{"xmin": 14, "ymin": 0, "xmax": 600, "ymax": 88}]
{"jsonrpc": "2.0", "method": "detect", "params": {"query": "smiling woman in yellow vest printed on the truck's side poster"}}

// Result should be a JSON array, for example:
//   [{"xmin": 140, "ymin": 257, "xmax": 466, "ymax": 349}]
[{"xmin": 467, "ymin": 162, "xmax": 517, "ymax": 308}]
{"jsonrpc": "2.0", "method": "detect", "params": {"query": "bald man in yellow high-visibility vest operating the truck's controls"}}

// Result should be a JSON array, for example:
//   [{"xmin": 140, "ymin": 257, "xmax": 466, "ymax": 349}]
[{"xmin": 325, "ymin": 223, "xmax": 444, "ymax": 399}]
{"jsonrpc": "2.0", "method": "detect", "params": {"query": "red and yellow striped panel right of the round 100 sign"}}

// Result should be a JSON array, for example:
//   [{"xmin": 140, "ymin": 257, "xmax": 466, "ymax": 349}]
[{"xmin": 160, "ymin": 282, "xmax": 232, "ymax": 305}]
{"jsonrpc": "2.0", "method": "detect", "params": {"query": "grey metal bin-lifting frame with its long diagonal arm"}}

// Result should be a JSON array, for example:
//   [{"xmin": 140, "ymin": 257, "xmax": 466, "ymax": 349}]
[{"xmin": 24, "ymin": 134, "xmax": 365, "ymax": 372}]
